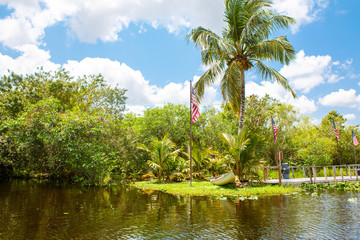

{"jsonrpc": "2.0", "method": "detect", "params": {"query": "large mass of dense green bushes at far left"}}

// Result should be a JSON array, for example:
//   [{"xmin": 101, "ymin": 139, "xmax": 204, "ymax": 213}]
[{"xmin": 0, "ymin": 70, "xmax": 129, "ymax": 184}]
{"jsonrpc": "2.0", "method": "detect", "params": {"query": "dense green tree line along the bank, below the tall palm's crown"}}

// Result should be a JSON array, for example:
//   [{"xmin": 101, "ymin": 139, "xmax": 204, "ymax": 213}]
[{"xmin": 0, "ymin": 69, "xmax": 359, "ymax": 185}]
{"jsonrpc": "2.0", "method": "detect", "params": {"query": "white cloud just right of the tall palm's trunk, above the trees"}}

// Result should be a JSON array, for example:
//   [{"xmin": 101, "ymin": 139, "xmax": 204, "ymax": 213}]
[{"xmin": 246, "ymin": 81, "xmax": 317, "ymax": 114}]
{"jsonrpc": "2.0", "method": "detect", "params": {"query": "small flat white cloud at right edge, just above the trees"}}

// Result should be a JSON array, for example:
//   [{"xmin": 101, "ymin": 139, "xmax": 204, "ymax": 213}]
[{"xmin": 319, "ymin": 89, "xmax": 360, "ymax": 108}]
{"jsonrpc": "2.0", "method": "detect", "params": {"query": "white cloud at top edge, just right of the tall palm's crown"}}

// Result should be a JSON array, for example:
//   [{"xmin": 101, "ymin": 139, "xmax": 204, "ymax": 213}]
[{"xmin": 273, "ymin": 0, "xmax": 329, "ymax": 32}]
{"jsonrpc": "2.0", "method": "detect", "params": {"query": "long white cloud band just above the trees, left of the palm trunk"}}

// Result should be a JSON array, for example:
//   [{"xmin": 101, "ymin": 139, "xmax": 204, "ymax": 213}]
[{"xmin": 0, "ymin": 45, "xmax": 220, "ymax": 113}]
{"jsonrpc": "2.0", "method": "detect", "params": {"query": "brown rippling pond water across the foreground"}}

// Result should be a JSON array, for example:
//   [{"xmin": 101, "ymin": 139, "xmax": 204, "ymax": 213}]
[{"xmin": 0, "ymin": 181, "xmax": 360, "ymax": 239}]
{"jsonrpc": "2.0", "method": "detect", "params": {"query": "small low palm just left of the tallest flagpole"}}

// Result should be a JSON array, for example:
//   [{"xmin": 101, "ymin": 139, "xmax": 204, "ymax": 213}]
[{"xmin": 138, "ymin": 134, "xmax": 181, "ymax": 181}]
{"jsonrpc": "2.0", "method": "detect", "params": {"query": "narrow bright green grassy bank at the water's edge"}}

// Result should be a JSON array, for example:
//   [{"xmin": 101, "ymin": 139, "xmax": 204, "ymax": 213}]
[{"xmin": 134, "ymin": 181, "xmax": 302, "ymax": 197}]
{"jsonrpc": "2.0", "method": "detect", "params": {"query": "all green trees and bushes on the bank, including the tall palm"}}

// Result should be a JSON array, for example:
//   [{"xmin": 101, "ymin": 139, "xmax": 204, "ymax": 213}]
[{"xmin": 0, "ymin": 0, "xmax": 359, "ymax": 185}]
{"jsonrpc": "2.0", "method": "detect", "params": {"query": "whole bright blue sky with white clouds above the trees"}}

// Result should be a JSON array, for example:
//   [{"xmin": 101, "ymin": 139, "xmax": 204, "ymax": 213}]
[{"xmin": 0, "ymin": 0, "xmax": 360, "ymax": 125}]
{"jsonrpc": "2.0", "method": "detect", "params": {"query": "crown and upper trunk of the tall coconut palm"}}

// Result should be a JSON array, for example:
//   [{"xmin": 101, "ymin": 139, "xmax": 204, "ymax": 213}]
[{"xmin": 186, "ymin": 0, "xmax": 296, "ymax": 133}]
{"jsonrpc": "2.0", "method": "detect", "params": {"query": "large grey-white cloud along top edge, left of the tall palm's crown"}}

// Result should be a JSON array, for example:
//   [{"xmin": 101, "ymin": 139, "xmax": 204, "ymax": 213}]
[{"xmin": 66, "ymin": 0, "xmax": 224, "ymax": 42}]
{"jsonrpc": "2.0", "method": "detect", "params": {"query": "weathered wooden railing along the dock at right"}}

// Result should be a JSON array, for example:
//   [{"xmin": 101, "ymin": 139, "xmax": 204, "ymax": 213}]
[{"xmin": 264, "ymin": 164, "xmax": 360, "ymax": 183}]
